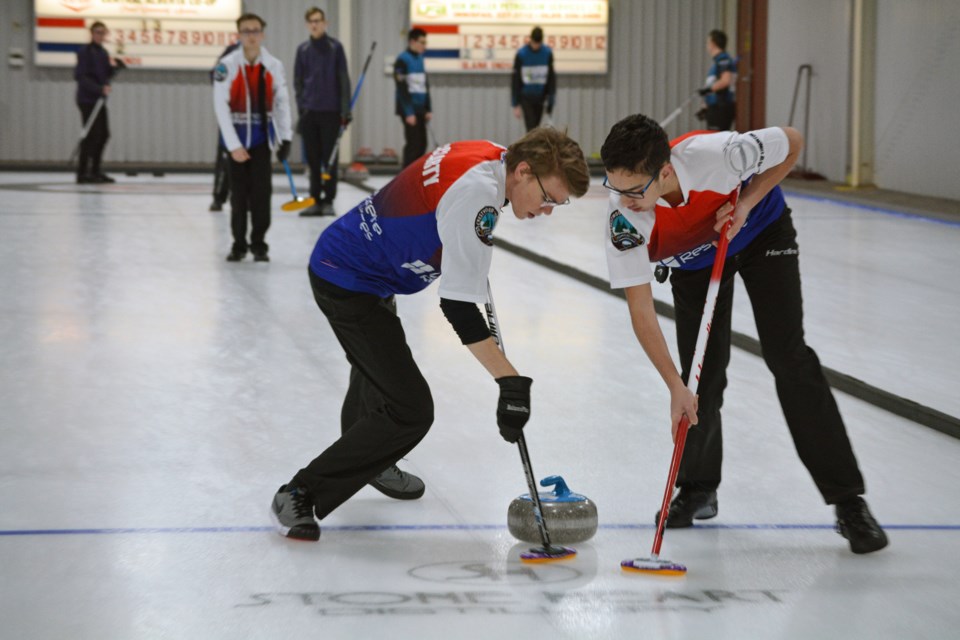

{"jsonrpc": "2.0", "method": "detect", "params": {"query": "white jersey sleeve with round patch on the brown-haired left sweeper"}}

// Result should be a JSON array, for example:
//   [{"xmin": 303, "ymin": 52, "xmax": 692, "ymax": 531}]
[{"xmin": 437, "ymin": 161, "xmax": 503, "ymax": 304}]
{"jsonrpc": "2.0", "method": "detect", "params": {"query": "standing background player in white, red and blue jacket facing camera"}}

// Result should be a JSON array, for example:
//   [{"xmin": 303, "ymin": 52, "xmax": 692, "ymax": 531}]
[{"xmin": 213, "ymin": 13, "xmax": 293, "ymax": 262}]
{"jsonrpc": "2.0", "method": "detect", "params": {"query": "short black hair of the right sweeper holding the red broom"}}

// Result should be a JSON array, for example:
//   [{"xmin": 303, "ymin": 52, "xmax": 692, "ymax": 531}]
[{"xmin": 600, "ymin": 113, "xmax": 670, "ymax": 177}]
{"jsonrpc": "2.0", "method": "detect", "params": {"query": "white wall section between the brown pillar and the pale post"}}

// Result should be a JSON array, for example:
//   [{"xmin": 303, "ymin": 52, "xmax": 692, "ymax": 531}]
[{"xmin": 766, "ymin": 0, "xmax": 851, "ymax": 182}]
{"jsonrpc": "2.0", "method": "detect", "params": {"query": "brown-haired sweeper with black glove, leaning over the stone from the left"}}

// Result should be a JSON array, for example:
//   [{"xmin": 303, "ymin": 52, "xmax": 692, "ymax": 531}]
[{"xmin": 272, "ymin": 128, "xmax": 590, "ymax": 540}]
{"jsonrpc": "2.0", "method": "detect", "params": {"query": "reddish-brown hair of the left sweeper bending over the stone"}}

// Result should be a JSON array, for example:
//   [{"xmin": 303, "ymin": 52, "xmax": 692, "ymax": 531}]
[{"xmin": 504, "ymin": 127, "xmax": 590, "ymax": 198}]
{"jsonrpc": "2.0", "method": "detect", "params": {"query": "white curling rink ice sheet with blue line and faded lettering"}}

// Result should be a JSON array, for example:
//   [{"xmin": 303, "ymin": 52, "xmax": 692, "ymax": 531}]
[{"xmin": 0, "ymin": 173, "xmax": 960, "ymax": 640}]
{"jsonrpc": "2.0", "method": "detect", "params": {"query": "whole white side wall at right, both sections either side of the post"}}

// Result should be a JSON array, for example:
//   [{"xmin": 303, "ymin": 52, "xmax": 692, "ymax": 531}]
[{"xmin": 767, "ymin": 0, "xmax": 960, "ymax": 200}]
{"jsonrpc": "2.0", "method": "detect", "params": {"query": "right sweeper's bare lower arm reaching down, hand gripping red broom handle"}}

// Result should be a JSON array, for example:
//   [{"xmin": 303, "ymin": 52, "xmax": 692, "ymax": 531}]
[{"xmin": 624, "ymin": 283, "xmax": 697, "ymax": 436}]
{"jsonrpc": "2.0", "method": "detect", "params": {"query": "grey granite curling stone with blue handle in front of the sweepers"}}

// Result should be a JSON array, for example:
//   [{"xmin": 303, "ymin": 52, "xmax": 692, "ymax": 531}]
[{"xmin": 507, "ymin": 476, "xmax": 597, "ymax": 544}]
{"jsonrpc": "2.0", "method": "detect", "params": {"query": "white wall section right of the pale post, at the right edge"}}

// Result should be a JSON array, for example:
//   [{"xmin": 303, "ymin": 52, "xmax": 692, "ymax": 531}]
[{"xmin": 875, "ymin": 0, "xmax": 960, "ymax": 200}]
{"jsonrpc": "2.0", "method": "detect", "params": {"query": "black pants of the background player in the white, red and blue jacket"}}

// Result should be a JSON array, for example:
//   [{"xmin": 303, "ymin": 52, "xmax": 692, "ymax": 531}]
[{"xmin": 230, "ymin": 143, "xmax": 273, "ymax": 253}]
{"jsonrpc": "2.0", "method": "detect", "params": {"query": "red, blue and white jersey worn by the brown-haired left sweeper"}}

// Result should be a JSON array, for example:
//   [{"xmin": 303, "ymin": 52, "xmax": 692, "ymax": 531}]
[{"xmin": 310, "ymin": 140, "xmax": 506, "ymax": 304}]
